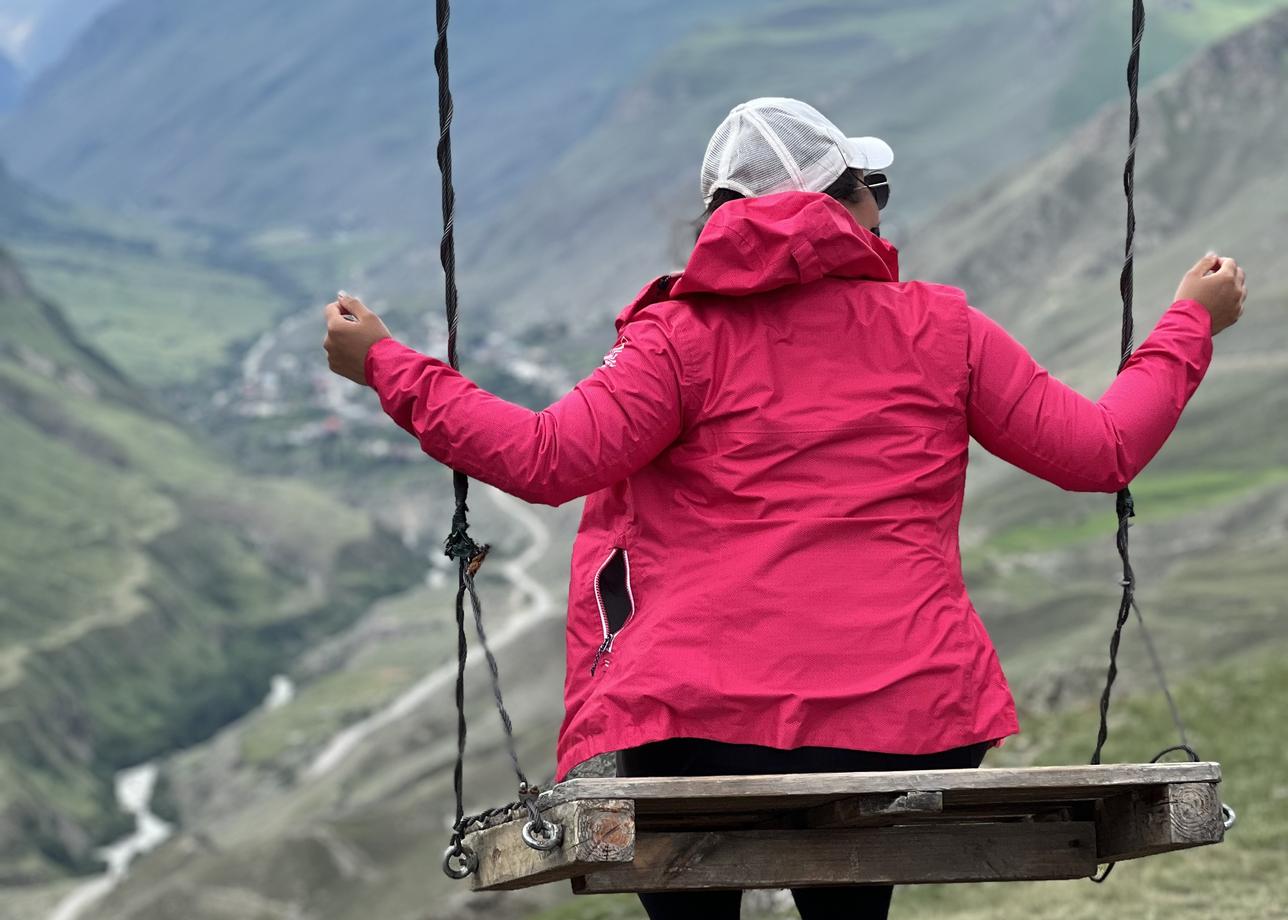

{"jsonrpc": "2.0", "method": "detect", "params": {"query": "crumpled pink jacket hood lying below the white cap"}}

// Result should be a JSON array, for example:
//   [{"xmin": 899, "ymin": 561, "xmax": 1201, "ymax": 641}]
[{"xmin": 616, "ymin": 192, "xmax": 899, "ymax": 331}]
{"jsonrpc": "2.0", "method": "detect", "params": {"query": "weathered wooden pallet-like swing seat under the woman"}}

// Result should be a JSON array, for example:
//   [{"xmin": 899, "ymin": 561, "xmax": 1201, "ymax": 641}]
[{"xmin": 465, "ymin": 763, "xmax": 1225, "ymax": 894}]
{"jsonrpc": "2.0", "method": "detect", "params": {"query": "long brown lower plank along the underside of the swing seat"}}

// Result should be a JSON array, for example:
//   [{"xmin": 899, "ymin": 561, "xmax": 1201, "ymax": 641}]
[{"xmin": 573, "ymin": 821, "xmax": 1096, "ymax": 894}]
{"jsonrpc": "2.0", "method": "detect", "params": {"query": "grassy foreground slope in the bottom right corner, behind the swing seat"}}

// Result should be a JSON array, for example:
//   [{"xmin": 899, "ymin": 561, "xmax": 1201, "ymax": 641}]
[{"xmin": 899, "ymin": 637, "xmax": 1288, "ymax": 920}]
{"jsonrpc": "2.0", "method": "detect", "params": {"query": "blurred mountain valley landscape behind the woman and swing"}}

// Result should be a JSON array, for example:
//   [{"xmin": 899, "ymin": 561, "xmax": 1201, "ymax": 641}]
[{"xmin": 0, "ymin": 0, "xmax": 1288, "ymax": 920}]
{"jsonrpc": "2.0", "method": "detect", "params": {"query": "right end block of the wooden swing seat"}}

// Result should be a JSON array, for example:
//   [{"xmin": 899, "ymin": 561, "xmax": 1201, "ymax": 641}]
[{"xmin": 1096, "ymin": 782, "xmax": 1225, "ymax": 862}]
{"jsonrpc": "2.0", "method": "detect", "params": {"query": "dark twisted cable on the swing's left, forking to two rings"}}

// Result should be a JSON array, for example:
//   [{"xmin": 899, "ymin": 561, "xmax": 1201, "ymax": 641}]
[{"xmin": 434, "ymin": 0, "xmax": 563, "ymax": 879}]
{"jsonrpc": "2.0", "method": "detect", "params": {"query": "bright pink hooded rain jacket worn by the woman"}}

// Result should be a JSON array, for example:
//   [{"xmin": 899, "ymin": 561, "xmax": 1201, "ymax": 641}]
[{"xmin": 366, "ymin": 192, "xmax": 1212, "ymax": 778}]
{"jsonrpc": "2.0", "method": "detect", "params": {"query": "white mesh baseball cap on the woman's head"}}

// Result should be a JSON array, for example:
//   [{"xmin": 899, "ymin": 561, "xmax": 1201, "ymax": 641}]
[{"xmin": 702, "ymin": 97, "xmax": 894, "ymax": 204}]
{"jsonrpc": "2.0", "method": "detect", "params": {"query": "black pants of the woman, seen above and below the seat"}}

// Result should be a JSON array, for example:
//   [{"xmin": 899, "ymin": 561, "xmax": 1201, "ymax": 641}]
[{"xmin": 617, "ymin": 738, "xmax": 992, "ymax": 920}]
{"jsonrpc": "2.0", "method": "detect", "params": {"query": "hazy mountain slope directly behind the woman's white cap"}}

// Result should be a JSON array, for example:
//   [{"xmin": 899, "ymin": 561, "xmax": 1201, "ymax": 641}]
[{"xmin": 460, "ymin": 0, "xmax": 1282, "ymax": 335}]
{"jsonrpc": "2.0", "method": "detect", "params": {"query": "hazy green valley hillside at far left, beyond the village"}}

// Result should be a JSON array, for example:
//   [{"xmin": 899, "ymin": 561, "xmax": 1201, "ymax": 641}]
[{"xmin": 0, "ymin": 153, "xmax": 307, "ymax": 388}]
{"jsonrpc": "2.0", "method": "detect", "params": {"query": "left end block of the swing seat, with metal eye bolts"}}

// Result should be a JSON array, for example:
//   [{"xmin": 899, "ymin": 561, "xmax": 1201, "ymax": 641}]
[{"xmin": 465, "ymin": 799, "xmax": 635, "ymax": 892}]
